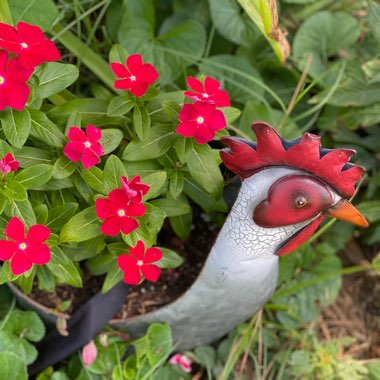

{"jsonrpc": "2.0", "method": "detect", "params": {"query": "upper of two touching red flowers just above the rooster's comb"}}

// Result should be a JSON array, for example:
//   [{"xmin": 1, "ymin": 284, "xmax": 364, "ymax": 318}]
[{"xmin": 185, "ymin": 77, "xmax": 230, "ymax": 107}]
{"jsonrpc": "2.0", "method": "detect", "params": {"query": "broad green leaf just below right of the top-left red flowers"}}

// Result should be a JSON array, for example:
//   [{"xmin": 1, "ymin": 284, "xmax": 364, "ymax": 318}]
[{"xmin": 35, "ymin": 62, "xmax": 79, "ymax": 99}]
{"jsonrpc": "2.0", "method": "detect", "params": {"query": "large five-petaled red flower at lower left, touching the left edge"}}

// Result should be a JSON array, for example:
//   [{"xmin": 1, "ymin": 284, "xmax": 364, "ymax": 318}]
[{"xmin": 0, "ymin": 217, "xmax": 50, "ymax": 275}]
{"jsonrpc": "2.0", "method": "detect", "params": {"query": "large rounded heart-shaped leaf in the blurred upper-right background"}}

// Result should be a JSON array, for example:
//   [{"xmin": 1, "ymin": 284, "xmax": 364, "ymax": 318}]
[{"xmin": 293, "ymin": 11, "xmax": 360, "ymax": 77}]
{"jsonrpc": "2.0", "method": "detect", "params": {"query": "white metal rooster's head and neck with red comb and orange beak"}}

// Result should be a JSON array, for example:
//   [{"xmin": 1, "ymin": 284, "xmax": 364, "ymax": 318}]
[{"xmin": 116, "ymin": 122, "xmax": 368, "ymax": 350}]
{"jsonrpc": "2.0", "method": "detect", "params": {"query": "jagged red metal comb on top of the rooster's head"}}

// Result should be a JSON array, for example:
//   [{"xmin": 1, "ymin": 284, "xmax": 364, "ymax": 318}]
[{"xmin": 220, "ymin": 122, "xmax": 365, "ymax": 198}]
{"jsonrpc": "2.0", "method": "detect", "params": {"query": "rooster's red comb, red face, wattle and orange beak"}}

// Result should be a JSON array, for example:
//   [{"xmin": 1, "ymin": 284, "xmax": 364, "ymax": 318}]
[{"xmin": 221, "ymin": 122, "xmax": 368, "ymax": 255}]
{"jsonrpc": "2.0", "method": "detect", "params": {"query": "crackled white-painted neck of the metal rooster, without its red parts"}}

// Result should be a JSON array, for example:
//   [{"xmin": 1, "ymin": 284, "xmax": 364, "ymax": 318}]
[{"xmin": 118, "ymin": 167, "xmax": 332, "ymax": 350}]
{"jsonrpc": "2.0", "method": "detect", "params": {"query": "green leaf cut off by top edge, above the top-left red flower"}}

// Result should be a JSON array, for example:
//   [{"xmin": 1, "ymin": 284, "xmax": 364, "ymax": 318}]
[{"xmin": 8, "ymin": 0, "xmax": 59, "ymax": 30}]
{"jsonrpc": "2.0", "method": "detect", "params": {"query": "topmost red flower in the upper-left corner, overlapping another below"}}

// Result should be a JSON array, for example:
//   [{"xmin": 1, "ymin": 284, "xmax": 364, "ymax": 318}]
[{"xmin": 0, "ymin": 21, "xmax": 61, "ymax": 68}]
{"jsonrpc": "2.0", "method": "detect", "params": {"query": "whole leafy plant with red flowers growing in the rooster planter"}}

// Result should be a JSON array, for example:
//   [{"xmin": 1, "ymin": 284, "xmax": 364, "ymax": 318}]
[{"xmin": 0, "ymin": 16, "xmax": 238, "ymax": 293}]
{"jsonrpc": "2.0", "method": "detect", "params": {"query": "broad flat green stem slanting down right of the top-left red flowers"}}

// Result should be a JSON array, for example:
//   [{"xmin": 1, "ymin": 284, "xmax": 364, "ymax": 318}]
[{"xmin": 53, "ymin": 24, "xmax": 115, "ymax": 91}]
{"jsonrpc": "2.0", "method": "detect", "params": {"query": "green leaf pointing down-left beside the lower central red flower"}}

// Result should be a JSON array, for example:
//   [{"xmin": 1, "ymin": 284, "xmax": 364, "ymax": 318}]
[{"xmin": 60, "ymin": 207, "xmax": 100, "ymax": 243}]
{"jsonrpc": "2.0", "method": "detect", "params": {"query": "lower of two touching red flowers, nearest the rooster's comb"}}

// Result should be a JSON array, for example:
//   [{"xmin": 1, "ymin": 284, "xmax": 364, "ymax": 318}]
[{"xmin": 176, "ymin": 102, "xmax": 226, "ymax": 144}]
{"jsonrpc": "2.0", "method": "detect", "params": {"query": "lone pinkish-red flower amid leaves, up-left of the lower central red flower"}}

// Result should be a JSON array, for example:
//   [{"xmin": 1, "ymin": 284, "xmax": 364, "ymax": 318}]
[{"xmin": 63, "ymin": 125, "xmax": 104, "ymax": 169}]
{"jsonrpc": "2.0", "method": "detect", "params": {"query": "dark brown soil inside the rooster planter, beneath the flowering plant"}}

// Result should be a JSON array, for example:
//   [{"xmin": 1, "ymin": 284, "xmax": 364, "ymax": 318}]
[{"xmin": 31, "ymin": 211, "xmax": 219, "ymax": 318}]
